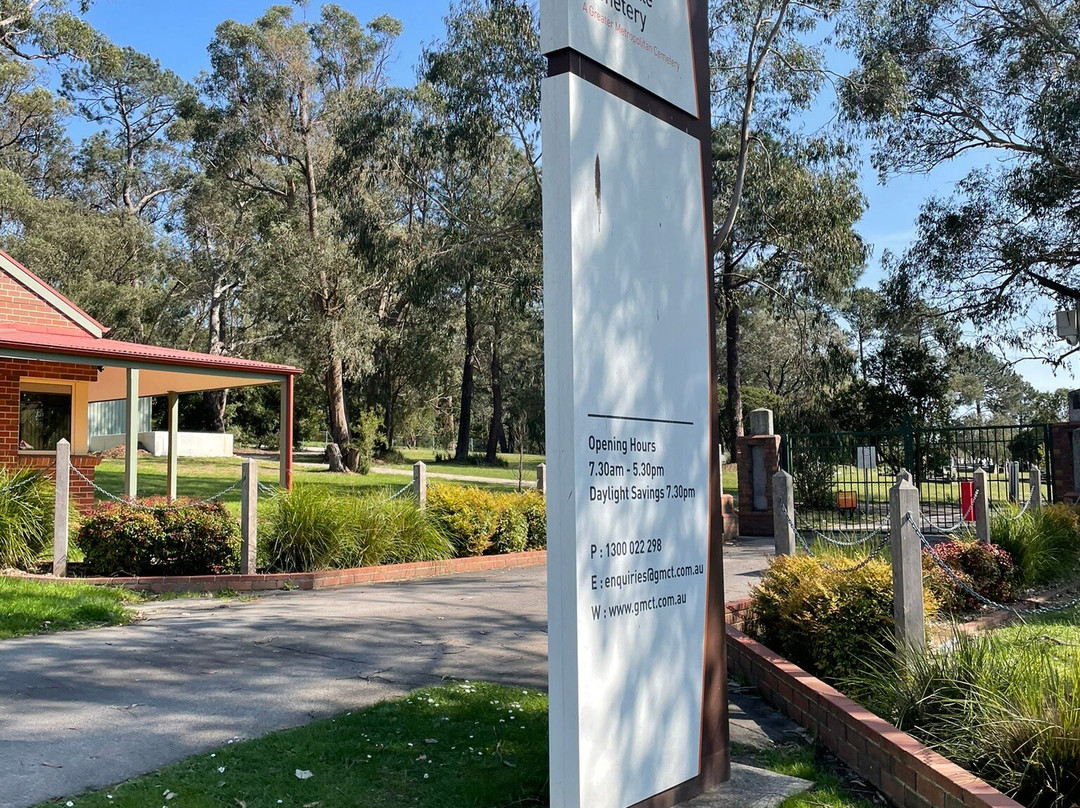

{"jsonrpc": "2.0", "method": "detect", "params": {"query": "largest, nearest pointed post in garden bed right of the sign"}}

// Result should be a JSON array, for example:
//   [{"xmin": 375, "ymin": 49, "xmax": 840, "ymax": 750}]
[{"xmin": 889, "ymin": 480, "xmax": 927, "ymax": 651}]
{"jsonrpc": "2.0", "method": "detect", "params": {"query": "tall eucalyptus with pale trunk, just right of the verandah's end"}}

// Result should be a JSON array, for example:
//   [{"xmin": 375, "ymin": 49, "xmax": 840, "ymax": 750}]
[{"xmin": 192, "ymin": 4, "xmax": 401, "ymax": 466}]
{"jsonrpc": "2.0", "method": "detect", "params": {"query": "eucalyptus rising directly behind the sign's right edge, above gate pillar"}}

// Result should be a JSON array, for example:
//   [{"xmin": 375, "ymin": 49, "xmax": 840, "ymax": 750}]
[{"xmin": 710, "ymin": 0, "xmax": 864, "ymax": 441}]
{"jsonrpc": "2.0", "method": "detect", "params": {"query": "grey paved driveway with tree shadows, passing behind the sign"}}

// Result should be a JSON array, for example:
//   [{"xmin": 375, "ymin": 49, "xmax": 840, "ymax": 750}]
[{"xmin": 0, "ymin": 540, "xmax": 771, "ymax": 808}]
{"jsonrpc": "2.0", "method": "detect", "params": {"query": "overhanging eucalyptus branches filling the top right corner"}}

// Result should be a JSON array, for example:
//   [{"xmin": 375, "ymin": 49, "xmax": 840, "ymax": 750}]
[{"xmin": 842, "ymin": 0, "xmax": 1080, "ymax": 360}]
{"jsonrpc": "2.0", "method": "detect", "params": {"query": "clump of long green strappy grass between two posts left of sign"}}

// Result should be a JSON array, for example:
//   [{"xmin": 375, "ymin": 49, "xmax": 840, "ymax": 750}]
[{"xmin": 261, "ymin": 485, "xmax": 454, "ymax": 573}]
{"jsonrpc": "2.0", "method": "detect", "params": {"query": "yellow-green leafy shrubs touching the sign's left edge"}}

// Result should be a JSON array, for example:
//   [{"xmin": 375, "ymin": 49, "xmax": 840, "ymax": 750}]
[{"xmin": 428, "ymin": 485, "xmax": 548, "ymax": 557}]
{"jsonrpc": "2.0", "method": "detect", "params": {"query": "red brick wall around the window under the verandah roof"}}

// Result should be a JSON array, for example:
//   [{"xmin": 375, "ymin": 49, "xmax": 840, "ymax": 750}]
[{"xmin": 0, "ymin": 360, "xmax": 99, "ymax": 508}]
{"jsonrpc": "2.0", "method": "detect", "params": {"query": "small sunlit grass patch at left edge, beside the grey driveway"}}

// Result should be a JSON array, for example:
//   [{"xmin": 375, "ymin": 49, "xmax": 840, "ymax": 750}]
[{"xmin": 0, "ymin": 578, "xmax": 140, "ymax": 639}]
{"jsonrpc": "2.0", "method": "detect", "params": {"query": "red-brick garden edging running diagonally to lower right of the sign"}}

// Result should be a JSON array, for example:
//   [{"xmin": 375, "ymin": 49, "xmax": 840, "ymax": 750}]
[{"xmin": 727, "ymin": 600, "xmax": 1024, "ymax": 808}]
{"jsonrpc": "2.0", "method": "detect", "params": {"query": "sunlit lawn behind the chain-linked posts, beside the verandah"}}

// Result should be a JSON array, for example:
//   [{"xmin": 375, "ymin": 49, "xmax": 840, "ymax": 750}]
[{"xmin": 94, "ymin": 457, "xmax": 413, "ymax": 516}]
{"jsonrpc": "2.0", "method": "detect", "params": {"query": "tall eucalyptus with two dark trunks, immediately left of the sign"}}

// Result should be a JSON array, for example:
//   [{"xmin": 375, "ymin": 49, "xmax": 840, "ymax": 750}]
[{"xmin": 422, "ymin": 0, "xmax": 544, "ymax": 461}]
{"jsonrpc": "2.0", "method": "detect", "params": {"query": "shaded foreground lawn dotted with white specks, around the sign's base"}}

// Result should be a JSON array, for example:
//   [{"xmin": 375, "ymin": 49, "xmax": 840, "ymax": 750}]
[{"xmin": 42, "ymin": 683, "xmax": 869, "ymax": 808}]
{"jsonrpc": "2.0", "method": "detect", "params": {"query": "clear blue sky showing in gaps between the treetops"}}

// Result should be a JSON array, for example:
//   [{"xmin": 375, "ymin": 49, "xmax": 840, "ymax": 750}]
[{"xmin": 86, "ymin": 0, "xmax": 1074, "ymax": 390}]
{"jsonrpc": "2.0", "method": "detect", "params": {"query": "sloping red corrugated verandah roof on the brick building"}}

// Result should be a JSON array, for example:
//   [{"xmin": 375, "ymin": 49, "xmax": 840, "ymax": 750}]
[{"xmin": 0, "ymin": 324, "xmax": 302, "ymax": 376}]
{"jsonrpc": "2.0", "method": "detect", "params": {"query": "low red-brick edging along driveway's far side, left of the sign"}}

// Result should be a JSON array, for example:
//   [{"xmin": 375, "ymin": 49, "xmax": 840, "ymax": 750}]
[{"xmin": 8, "ymin": 550, "xmax": 548, "ymax": 594}]
